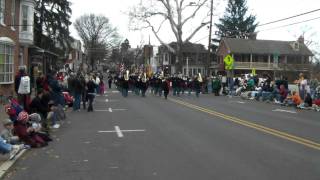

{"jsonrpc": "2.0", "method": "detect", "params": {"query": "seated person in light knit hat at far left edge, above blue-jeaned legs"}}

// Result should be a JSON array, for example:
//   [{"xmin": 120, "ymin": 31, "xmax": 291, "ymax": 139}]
[{"xmin": 1, "ymin": 119, "xmax": 19, "ymax": 144}]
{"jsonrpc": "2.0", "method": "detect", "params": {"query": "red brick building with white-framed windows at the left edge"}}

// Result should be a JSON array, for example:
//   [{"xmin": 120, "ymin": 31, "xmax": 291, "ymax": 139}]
[{"xmin": 0, "ymin": 0, "xmax": 35, "ymax": 96}]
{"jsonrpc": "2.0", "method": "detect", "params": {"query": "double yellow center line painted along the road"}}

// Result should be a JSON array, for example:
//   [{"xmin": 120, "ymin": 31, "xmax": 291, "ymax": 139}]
[{"xmin": 169, "ymin": 98, "xmax": 320, "ymax": 150}]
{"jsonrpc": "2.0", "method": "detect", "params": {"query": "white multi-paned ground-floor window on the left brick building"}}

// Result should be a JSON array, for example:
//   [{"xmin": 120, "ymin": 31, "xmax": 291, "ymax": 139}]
[{"xmin": 0, "ymin": 44, "xmax": 14, "ymax": 84}]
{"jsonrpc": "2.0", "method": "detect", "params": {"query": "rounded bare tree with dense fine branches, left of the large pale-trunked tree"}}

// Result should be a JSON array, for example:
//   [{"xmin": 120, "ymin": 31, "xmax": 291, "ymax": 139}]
[{"xmin": 74, "ymin": 14, "xmax": 120, "ymax": 68}]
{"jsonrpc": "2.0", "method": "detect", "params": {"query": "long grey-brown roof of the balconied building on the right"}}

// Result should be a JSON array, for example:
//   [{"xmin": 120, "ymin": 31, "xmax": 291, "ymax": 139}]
[{"xmin": 223, "ymin": 38, "xmax": 313, "ymax": 56}]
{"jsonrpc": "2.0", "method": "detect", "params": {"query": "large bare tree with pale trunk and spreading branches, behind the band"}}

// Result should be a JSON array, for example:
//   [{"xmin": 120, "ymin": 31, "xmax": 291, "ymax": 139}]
[{"xmin": 129, "ymin": 0, "xmax": 218, "ymax": 71}]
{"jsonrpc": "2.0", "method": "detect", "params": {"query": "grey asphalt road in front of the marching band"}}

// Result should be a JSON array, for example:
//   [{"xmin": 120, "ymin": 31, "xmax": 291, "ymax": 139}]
[{"xmin": 6, "ymin": 91, "xmax": 320, "ymax": 180}]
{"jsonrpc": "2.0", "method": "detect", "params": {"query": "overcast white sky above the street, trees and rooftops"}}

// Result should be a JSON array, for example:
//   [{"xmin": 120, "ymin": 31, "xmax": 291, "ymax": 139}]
[{"xmin": 70, "ymin": 0, "xmax": 320, "ymax": 47}]
